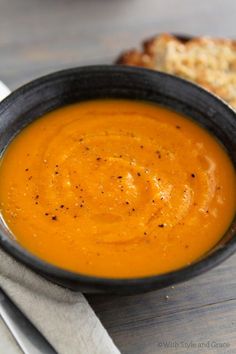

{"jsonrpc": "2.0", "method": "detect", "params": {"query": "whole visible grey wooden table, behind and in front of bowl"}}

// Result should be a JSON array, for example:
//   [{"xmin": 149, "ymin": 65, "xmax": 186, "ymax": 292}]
[{"xmin": 0, "ymin": 0, "xmax": 236, "ymax": 354}]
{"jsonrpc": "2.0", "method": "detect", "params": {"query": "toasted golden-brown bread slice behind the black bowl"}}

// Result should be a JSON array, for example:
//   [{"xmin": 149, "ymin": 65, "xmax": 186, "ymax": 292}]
[{"xmin": 117, "ymin": 33, "xmax": 236, "ymax": 109}]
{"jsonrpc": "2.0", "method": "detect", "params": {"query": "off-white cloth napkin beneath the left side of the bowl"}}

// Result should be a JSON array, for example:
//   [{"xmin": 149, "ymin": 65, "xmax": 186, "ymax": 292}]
[{"xmin": 0, "ymin": 81, "xmax": 120, "ymax": 354}]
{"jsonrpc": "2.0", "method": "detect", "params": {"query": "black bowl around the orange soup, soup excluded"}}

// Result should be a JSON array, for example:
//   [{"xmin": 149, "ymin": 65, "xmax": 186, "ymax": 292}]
[{"xmin": 0, "ymin": 66, "xmax": 236, "ymax": 294}]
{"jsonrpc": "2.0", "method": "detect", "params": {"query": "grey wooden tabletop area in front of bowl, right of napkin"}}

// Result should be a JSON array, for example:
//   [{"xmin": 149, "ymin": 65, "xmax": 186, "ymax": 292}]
[{"xmin": 87, "ymin": 256, "xmax": 236, "ymax": 354}]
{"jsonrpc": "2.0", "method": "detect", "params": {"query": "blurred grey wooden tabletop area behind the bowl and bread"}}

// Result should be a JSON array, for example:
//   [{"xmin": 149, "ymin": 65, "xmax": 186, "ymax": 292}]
[{"xmin": 0, "ymin": 0, "xmax": 236, "ymax": 88}]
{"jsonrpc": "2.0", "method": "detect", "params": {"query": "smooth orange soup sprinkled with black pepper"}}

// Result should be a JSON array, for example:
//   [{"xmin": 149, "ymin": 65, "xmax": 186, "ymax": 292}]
[{"xmin": 0, "ymin": 100, "xmax": 236, "ymax": 278}]
